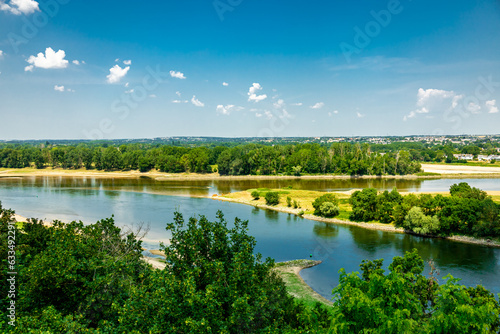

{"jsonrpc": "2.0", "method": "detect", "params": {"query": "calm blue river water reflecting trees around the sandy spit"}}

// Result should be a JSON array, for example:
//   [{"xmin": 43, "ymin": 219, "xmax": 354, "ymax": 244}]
[{"xmin": 0, "ymin": 177, "xmax": 500, "ymax": 298}]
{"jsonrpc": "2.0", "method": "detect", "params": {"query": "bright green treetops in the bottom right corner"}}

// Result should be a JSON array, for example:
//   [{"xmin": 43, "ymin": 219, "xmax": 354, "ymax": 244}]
[{"xmin": 332, "ymin": 250, "xmax": 500, "ymax": 333}]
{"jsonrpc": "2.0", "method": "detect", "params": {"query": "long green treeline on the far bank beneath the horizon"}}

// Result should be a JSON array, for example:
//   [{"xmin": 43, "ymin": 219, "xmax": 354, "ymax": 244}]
[{"xmin": 0, "ymin": 143, "xmax": 421, "ymax": 176}]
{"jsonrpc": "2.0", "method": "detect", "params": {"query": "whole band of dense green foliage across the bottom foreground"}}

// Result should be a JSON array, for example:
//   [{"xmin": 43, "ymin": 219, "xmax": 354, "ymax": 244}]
[{"xmin": 0, "ymin": 202, "xmax": 500, "ymax": 333}]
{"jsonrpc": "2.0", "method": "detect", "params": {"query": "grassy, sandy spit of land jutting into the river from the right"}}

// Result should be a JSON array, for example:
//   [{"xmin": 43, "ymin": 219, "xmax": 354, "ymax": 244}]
[{"xmin": 211, "ymin": 190, "xmax": 500, "ymax": 248}]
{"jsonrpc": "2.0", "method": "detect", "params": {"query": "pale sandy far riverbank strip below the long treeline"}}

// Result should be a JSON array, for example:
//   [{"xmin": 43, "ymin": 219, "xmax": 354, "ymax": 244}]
[{"xmin": 0, "ymin": 164, "xmax": 500, "ymax": 181}]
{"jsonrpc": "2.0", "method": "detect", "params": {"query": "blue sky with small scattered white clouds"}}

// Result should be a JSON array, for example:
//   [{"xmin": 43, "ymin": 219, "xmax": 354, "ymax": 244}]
[{"xmin": 0, "ymin": 0, "xmax": 500, "ymax": 139}]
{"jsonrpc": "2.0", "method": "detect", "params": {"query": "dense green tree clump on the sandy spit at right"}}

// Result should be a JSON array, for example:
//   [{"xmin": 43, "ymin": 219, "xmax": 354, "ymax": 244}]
[{"xmin": 349, "ymin": 182, "xmax": 500, "ymax": 237}]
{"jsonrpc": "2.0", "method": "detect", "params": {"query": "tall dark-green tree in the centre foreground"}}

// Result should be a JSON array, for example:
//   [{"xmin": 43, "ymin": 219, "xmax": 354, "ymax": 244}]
[{"xmin": 115, "ymin": 212, "xmax": 293, "ymax": 333}]
